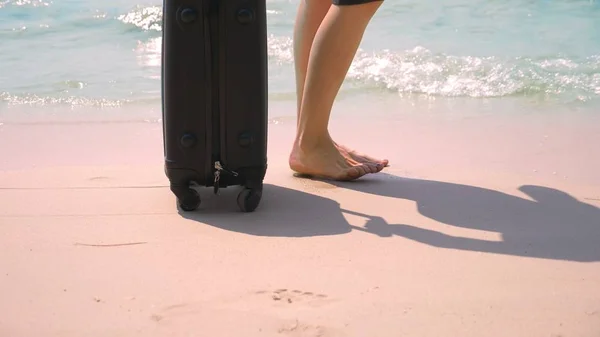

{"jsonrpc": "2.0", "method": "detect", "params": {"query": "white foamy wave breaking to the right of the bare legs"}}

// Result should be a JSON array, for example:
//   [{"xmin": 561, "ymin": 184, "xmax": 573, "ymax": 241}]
[{"xmin": 348, "ymin": 47, "xmax": 600, "ymax": 100}]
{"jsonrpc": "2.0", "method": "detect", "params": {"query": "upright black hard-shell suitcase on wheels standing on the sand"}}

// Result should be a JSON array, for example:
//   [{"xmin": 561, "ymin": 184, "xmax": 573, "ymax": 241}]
[{"xmin": 162, "ymin": 0, "xmax": 268, "ymax": 212}]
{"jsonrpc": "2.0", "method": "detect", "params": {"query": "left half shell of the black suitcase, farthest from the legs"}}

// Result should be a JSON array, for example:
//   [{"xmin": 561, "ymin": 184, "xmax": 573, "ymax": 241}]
[{"xmin": 162, "ymin": 0, "xmax": 212, "ymax": 184}]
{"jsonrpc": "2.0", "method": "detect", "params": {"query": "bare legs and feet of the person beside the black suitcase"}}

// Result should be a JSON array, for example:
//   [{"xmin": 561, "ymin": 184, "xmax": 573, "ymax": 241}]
[{"xmin": 290, "ymin": 0, "xmax": 387, "ymax": 180}]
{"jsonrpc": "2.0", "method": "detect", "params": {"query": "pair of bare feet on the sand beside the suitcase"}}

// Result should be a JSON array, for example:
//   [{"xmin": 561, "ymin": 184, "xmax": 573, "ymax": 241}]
[{"xmin": 289, "ymin": 136, "xmax": 385, "ymax": 181}]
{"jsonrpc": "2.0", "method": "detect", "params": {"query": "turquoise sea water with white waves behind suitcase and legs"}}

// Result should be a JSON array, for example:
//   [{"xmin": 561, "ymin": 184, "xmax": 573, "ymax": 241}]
[{"xmin": 0, "ymin": 0, "xmax": 600, "ymax": 109}]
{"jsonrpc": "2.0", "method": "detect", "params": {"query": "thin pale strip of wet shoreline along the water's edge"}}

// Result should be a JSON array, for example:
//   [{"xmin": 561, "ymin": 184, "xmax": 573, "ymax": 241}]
[{"xmin": 0, "ymin": 86, "xmax": 600, "ymax": 124}]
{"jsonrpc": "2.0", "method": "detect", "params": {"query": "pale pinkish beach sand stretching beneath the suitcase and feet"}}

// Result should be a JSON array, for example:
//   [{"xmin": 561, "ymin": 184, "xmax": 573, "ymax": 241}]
[{"xmin": 0, "ymin": 105, "xmax": 600, "ymax": 337}]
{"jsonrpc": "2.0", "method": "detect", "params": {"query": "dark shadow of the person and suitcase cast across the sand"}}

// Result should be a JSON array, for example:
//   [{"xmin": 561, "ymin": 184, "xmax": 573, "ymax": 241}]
[{"xmin": 182, "ymin": 174, "xmax": 600, "ymax": 262}]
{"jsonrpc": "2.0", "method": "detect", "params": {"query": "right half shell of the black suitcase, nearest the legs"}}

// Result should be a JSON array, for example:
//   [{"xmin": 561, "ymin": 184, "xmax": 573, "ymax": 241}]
[{"xmin": 219, "ymin": 0, "xmax": 268, "ymax": 181}]
